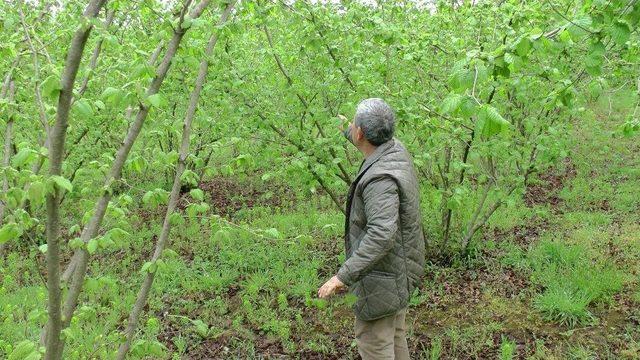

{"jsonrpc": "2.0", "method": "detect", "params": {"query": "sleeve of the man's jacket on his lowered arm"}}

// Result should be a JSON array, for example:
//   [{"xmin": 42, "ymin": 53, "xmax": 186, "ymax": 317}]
[{"xmin": 338, "ymin": 178, "xmax": 400, "ymax": 286}]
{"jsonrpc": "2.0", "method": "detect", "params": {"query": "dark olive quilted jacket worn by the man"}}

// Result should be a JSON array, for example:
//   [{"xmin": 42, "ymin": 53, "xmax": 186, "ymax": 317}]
[{"xmin": 338, "ymin": 139, "xmax": 424, "ymax": 320}]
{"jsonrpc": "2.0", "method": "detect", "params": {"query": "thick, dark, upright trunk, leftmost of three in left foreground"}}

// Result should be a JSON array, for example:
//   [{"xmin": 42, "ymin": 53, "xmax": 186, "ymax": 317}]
[{"xmin": 45, "ymin": 0, "xmax": 106, "ymax": 360}]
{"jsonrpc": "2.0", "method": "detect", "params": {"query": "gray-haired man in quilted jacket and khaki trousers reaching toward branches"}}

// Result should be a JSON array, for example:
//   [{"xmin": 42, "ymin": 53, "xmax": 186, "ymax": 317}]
[{"xmin": 318, "ymin": 99, "xmax": 425, "ymax": 360}]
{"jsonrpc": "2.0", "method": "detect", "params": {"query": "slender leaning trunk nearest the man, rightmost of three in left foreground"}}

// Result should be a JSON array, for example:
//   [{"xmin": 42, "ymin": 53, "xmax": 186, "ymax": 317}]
[{"xmin": 116, "ymin": 0, "xmax": 235, "ymax": 360}]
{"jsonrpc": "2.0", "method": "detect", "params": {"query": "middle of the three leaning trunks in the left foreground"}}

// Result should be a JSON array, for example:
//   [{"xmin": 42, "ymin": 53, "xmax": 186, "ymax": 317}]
[{"xmin": 54, "ymin": 0, "xmax": 210, "ymax": 352}]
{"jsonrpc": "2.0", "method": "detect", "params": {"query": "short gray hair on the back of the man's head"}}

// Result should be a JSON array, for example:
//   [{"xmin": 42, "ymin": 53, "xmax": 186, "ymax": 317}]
[{"xmin": 355, "ymin": 98, "xmax": 396, "ymax": 146}]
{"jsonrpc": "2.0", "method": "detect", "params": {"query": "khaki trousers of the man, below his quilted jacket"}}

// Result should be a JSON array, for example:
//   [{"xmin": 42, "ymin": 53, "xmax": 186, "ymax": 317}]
[{"xmin": 355, "ymin": 308, "xmax": 409, "ymax": 360}]
